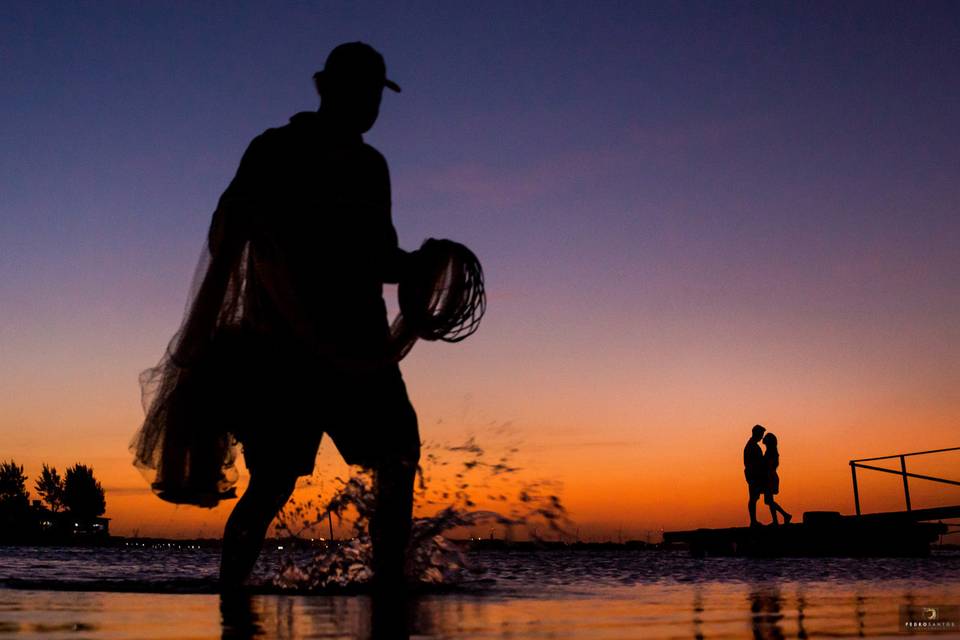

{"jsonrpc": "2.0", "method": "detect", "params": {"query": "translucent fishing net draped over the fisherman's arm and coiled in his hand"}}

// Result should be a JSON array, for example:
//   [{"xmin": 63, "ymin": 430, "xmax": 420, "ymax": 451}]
[{"xmin": 131, "ymin": 228, "xmax": 486, "ymax": 507}]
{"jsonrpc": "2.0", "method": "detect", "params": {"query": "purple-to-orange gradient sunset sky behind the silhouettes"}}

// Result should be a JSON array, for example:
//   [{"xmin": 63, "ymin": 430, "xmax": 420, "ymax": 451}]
[{"xmin": 0, "ymin": 2, "xmax": 960, "ymax": 537}]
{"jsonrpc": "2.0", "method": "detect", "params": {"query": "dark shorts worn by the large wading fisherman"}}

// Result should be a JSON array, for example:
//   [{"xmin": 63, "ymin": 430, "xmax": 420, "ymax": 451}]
[{"xmin": 208, "ymin": 332, "xmax": 420, "ymax": 476}]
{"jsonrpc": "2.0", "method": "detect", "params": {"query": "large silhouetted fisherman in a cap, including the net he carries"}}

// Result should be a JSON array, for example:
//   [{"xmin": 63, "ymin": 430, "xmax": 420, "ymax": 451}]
[{"xmin": 132, "ymin": 42, "xmax": 485, "ymax": 591}]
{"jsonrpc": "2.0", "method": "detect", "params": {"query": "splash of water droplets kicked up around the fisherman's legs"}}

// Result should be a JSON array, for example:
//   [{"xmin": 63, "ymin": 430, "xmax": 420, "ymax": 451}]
[{"xmin": 272, "ymin": 438, "xmax": 571, "ymax": 591}]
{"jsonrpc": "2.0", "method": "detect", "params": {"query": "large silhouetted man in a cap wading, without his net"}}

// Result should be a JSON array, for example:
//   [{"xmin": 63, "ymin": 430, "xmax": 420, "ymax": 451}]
[{"xmin": 218, "ymin": 42, "xmax": 420, "ymax": 589}]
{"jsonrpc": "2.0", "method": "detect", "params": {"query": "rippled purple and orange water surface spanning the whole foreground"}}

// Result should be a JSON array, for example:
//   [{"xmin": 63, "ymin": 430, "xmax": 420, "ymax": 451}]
[{"xmin": 0, "ymin": 547, "xmax": 960, "ymax": 639}]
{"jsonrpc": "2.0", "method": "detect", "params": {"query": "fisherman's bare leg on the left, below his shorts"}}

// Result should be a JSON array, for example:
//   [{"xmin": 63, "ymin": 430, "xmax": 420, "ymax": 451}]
[{"xmin": 220, "ymin": 472, "xmax": 297, "ymax": 588}]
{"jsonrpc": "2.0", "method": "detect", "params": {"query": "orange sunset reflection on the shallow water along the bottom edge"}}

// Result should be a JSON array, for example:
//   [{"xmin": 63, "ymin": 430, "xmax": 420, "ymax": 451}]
[{"xmin": 0, "ymin": 580, "xmax": 960, "ymax": 640}]
